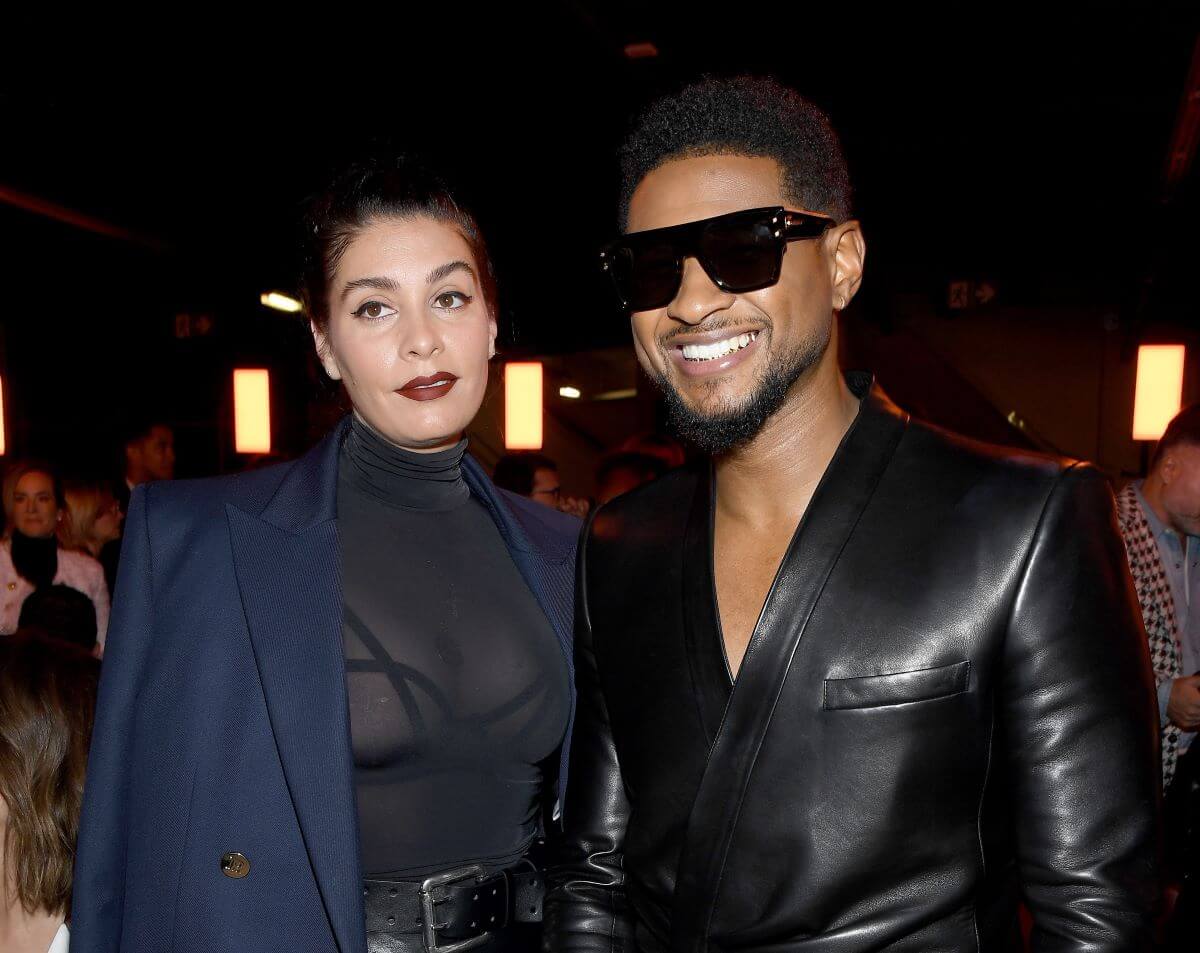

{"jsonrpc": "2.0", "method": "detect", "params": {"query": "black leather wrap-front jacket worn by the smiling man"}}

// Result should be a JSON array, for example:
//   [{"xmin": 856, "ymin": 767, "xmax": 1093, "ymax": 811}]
[{"xmin": 546, "ymin": 376, "xmax": 1159, "ymax": 953}]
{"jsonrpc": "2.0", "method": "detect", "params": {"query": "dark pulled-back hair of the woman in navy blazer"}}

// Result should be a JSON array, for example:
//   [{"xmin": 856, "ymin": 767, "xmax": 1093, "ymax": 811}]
[{"xmin": 301, "ymin": 156, "xmax": 497, "ymax": 331}]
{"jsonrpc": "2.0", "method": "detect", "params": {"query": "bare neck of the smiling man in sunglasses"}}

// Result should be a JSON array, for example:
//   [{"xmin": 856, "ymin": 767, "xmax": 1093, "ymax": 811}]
[{"xmin": 713, "ymin": 354, "xmax": 859, "ymax": 526}]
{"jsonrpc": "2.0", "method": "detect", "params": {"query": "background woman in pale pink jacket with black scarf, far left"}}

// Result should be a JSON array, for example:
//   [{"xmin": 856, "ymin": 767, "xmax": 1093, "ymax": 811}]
[{"xmin": 0, "ymin": 461, "xmax": 108, "ymax": 652}]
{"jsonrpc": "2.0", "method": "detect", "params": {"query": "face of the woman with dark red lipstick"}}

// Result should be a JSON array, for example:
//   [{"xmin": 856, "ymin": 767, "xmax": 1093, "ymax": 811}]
[{"xmin": 313, "ymin": 216, "xmax": 496, "ymax": 450}]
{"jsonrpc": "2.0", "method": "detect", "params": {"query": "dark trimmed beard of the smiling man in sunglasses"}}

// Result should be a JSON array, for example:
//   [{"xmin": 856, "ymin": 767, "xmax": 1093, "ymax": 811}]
[{"xmin": 650, "ymin": 312, "xmax": 833, "ymax": 456}]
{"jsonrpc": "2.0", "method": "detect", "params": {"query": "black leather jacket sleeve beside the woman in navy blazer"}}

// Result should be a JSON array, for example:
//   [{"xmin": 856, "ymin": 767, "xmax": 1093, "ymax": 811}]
[{"xmin": 544, "ymin": 523, "xmax": 635, "ymax": 953}]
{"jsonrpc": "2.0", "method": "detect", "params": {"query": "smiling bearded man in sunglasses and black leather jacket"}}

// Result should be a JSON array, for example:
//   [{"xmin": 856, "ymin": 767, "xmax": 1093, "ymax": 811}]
[{"xmin": 547, "ymin": 78, "xmax": 1158, "ymax": 953}]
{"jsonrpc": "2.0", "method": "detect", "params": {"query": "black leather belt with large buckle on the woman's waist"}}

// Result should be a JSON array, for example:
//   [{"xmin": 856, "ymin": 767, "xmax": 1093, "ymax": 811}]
[{"xmin": 362, "ymin": 859, "xmax": 546, "ymax": 953}]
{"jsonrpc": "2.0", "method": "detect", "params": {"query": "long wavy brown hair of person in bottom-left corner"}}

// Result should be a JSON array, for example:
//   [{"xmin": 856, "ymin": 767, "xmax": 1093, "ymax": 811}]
[{"xmin": 0, "ymin": 630, "xmax": 100, "ymax": 915}]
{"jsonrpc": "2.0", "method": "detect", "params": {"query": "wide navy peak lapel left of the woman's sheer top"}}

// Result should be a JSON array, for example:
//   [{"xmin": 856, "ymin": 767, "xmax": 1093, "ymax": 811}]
[{"xmin": 227, "ymin": 422, "xmax": 366, "ymax": 953}]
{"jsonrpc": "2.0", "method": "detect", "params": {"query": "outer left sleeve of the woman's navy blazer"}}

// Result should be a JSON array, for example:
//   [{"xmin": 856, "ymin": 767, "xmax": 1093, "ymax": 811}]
[{"xmin": 71, "ymin": 486, "xmax": 154, "ymax": 953}]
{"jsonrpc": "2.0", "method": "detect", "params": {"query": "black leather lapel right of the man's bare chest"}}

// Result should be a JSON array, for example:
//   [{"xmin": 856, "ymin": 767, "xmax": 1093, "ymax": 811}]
[{"xmin": 671, "ymin": 376, "xmax": 907, "ymax": 953}]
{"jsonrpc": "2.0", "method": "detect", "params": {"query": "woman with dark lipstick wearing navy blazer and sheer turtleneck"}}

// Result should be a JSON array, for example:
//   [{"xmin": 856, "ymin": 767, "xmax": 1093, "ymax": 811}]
[{"xmin": 74, "ymin": 162, "xmax": 577, "ymax": 953}]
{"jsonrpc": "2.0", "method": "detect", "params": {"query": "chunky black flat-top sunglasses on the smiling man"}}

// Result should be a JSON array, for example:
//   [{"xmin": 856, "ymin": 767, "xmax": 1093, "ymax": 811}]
[{"xmin": 600, "ymin": 205, "xmax": 834, "ymax": 311}]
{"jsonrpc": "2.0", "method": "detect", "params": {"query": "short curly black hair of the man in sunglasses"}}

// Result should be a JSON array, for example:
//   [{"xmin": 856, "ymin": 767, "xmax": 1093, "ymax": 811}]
[{"xmin": 620, "ymin": 76, "xmax": 851, "ymax": 228}]
